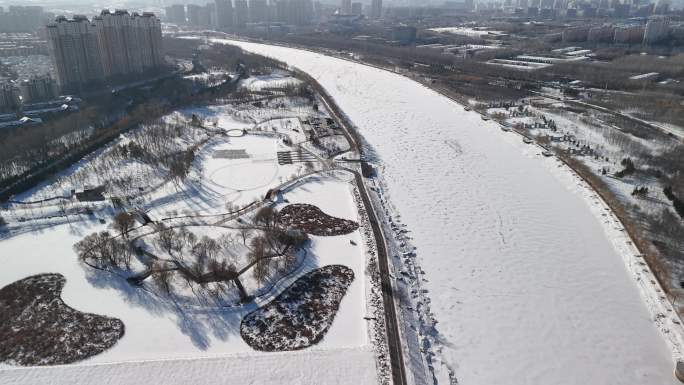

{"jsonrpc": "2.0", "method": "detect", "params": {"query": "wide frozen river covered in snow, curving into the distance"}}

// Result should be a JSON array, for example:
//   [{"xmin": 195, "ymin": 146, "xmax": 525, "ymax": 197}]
[{"xmin": 222, "ymin": 42, "xmax": 677, "ymax": 385}]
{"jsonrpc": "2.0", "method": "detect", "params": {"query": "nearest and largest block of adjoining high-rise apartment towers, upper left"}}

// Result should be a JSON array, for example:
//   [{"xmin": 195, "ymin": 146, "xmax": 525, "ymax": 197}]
[{"xmin": 46, "ymin": 10, "xmax": 162, "ymax": 92}]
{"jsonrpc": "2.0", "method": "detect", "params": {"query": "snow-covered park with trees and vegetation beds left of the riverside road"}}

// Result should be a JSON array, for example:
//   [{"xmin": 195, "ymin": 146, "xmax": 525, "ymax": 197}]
[{"xmin": 0, "ymin": 75, "xmax": 377, "ymax": 385}]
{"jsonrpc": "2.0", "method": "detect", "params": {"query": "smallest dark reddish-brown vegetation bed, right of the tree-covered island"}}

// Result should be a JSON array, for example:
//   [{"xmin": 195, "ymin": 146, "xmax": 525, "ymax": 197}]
[{"xmin": 278, "ymin": 203, "xmax": 359, "ymax": 236}]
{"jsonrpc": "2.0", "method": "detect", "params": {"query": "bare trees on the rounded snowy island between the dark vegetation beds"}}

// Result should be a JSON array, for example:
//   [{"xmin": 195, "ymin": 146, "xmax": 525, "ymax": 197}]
[{"xmin": 74, "ymin": 207, "xmax": 308, "ymax": 301}]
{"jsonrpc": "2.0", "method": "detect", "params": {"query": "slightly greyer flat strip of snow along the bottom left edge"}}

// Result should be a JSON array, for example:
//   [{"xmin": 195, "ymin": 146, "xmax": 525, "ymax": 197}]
[{"xmin": 0, "ymin": 349, "xmax": 375, "ymax": 385}]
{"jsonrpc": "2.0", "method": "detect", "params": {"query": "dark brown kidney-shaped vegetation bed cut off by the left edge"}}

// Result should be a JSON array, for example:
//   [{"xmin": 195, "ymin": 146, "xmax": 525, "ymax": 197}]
[{"xmin": 0, "ymin": 274, "xmax": 124, "ymax": 366}]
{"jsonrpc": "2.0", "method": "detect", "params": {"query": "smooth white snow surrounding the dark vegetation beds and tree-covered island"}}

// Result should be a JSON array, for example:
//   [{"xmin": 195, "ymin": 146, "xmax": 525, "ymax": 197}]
[{"xmin": 0, "ymin": 174, "xmax": 375, "ymax": 384}]
